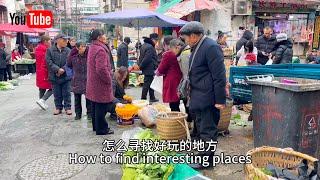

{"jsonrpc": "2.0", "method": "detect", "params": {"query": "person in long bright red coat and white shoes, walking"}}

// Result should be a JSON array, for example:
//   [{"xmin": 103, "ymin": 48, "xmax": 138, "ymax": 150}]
[{"xmin": 35, "ymin": 35, "xmax": 53, "ymax": 110}]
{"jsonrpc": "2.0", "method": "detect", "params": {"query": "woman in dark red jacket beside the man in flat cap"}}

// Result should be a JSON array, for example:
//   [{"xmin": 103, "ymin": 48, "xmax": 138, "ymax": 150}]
[{"xmin": 156, "ymin": 39, "xmax": 183, "ymax": 111}]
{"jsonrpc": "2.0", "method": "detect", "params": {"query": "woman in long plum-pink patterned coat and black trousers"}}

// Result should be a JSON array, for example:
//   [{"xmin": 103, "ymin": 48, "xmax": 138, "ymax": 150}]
[{"xmin": 86, "ymin": 29, "xmax": 115, "ymax": 135}]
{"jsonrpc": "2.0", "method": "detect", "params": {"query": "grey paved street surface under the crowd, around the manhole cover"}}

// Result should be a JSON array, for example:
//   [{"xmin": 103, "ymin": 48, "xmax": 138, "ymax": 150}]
[{"xmin": 0, "ymin": 76, "xmax": 253, "ymax": 180}]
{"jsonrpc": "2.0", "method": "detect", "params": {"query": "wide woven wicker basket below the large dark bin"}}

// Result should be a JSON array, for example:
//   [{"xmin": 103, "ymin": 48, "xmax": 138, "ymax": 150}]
[{"xmin": 244, "ymin": 146, "xmax": 318, "ymax": 180}]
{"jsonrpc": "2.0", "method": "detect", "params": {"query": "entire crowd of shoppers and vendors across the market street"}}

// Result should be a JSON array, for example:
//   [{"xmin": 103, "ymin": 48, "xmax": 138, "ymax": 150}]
[{"xmin": 0, "ymin": 21, "xmax": 320, "ymax": 169}]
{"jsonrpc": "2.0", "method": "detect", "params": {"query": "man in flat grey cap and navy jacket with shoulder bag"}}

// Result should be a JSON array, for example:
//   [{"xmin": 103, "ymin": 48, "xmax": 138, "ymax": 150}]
[{"xmin": 180, "ymin": 21, "xmax": 226, "ymax": 169}]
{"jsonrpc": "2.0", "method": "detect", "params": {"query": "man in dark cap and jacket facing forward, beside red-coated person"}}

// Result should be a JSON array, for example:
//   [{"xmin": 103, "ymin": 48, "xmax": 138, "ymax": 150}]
[{"xmin": 46, "ymin": 34, "xmax": 72, "ymax": 115}]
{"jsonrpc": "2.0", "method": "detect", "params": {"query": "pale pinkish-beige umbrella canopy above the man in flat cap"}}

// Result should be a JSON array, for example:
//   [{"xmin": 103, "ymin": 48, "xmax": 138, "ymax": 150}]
[{"xmin": 164, "ymin": 0, "xmax": 224, "ymax": 19}]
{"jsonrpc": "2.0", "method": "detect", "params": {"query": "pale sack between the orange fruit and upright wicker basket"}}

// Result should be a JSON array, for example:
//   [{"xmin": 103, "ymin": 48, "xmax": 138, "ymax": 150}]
[{"xmin": 138, "ymin": 103, "xmax": 171, "ymax": 127}]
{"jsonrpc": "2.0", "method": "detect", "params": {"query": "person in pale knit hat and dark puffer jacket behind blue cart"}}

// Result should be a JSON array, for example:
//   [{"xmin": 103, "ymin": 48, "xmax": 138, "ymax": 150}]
[{"xmin": 273, "ymin": 33, "xmax": 293, "ymax": 64}]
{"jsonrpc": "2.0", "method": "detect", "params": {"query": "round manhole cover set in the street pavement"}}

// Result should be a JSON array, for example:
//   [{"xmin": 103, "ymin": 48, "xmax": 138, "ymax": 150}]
[{"xmin": 17, "ymin": 154, "xmax": 87, "ymax": 180}]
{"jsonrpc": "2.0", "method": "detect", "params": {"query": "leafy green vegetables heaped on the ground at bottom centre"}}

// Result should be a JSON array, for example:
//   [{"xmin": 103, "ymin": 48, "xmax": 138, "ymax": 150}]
[{"xmin": 122, "ymin": 129, "xmax": 174, "ymax": 180}]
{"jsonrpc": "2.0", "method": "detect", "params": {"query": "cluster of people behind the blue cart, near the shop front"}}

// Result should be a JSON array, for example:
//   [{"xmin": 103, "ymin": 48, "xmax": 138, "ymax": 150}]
[{"xmin": 217, "ymin": 27, "xmax": 293, "ymax": 66}]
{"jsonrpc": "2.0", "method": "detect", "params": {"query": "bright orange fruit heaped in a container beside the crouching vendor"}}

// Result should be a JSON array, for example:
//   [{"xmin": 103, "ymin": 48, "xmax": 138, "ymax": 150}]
[{"xmin": 116, "ymin": 104, "xmax": 138, "ymax": 125}]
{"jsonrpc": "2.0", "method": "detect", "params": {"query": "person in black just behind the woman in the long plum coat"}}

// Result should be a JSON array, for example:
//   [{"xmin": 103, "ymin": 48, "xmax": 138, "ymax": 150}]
[{"xmin": 117, "ymin": 37, "xmax": 131, "ymax": 68}]
